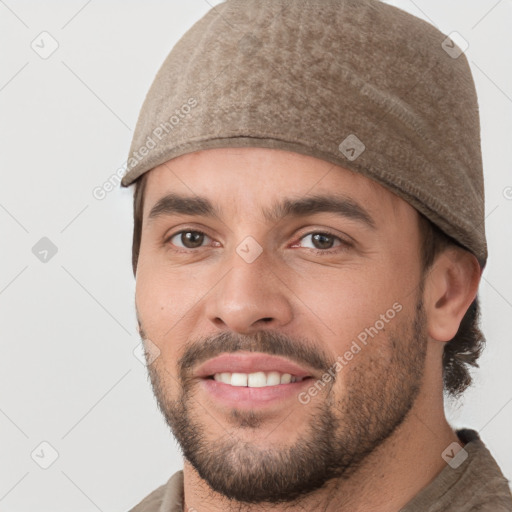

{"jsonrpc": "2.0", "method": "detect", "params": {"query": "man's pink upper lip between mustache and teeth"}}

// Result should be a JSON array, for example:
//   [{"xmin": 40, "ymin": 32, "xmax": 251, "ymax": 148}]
[{"xmin": 194, "ymin": 352, "xmax": 313, "ymax": 378}]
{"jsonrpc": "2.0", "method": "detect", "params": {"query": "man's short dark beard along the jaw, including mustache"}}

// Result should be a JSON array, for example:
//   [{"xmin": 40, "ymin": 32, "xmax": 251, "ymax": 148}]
[{"xmin": 141, "ymin": 287, "xmax": 428, "ymax": 504}]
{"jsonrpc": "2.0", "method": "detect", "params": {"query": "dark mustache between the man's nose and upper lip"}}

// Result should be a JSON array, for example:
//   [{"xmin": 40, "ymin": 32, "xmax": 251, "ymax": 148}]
[{"xmin": 178, "ymin": 331, "xmax": 335, "ymax": 376}]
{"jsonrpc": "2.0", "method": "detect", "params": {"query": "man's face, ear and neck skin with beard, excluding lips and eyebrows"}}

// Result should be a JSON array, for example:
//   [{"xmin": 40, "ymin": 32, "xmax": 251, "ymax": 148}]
[{"xmin": 136, "ymin": 148, "xmax": 480, "ymax": 512}]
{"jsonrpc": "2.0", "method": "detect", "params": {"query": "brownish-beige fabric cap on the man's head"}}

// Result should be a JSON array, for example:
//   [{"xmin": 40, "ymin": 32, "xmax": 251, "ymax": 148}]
[{"xmin": 122, "ymin": 0, "xmax": 487, "ymax": 267}]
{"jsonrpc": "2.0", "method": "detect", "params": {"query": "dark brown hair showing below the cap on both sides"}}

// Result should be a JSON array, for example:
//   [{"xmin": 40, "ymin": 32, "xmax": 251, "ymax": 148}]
[{"xmin": 132, "ymin": 173, "xmax": 485, "ymax": 397}]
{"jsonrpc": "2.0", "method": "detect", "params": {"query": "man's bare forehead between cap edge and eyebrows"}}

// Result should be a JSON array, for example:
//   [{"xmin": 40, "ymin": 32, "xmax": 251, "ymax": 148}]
[{"xmin": 144, "ymin": 147, "xmax": 415, "ymax": 222}]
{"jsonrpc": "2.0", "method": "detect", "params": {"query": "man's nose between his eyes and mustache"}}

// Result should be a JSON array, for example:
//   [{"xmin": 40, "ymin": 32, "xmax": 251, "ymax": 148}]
[{"xmin": 206, "ymin": 252, "xmax": 293, "ymax": 334}]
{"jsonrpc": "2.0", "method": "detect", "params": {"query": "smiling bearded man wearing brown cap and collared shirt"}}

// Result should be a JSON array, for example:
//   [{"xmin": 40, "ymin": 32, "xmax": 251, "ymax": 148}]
[{"xmin": 123, "ymin": 0, "xmax": 512, "ymax": 512}]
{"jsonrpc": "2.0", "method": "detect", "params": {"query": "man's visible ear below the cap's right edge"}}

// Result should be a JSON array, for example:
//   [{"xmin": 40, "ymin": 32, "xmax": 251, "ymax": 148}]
[{"xmin": 424, "ymin": 247, "xmax": 482, "ymax": 341}]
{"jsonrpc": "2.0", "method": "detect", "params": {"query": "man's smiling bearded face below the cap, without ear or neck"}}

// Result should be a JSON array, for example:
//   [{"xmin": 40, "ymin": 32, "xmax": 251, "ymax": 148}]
[{"xmin": 136, "ymin": 148, "xmax": 427, "ymax": 503}]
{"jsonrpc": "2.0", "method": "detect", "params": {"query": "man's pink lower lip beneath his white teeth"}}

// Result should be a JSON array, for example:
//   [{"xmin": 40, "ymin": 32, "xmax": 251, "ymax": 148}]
[{"xmin": 201, "ymin": 378, "xmax": 312, "ymax": 409}]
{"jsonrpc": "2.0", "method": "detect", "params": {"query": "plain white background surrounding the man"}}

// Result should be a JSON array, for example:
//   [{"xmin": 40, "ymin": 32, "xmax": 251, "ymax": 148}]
[{"xmin": 0, "ymin": 0, "xmax": 512, "ymax": 512}]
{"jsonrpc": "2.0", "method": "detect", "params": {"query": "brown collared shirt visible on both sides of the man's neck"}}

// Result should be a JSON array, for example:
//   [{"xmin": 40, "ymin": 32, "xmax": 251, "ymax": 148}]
[{"xmin": 129, "ymin": 429, "xmax": 512, "ymax": 512}]
